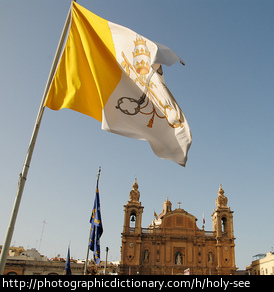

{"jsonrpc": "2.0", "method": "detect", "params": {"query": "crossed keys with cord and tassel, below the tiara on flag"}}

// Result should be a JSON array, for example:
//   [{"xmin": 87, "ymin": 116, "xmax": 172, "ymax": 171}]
[{"xmin": 116, "ymin": 52, "xmax": 183, "ymax": 128}]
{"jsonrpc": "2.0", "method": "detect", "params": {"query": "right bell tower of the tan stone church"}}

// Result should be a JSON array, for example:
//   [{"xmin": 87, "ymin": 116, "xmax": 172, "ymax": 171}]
[{"xmin": 211, "ymin": 185, "xmax": 237, "ymax": 275}]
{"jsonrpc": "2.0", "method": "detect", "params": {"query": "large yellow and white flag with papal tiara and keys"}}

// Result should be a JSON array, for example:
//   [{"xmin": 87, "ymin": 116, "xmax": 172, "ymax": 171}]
[{"xmin": 44, "ymin": 2, "xmax": 191, "ymax": 166}]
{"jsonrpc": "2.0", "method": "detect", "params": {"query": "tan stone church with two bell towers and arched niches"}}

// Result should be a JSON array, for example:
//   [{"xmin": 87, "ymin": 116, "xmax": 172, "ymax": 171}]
[{"xmin": 120, "ymin": 180, "xmax": 237, "ymax": 275}]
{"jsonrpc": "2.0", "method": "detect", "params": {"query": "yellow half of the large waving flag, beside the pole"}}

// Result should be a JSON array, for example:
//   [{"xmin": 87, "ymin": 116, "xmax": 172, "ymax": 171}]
[{"xmin": 45, "ymin": 2, "xmax": 122, "ymax": 121}]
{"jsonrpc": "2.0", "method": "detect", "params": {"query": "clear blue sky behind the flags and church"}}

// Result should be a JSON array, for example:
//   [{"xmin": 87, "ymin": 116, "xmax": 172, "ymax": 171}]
[{"xmin": 0, "ymin": 0, "xmax": 274, "ymax": 269}]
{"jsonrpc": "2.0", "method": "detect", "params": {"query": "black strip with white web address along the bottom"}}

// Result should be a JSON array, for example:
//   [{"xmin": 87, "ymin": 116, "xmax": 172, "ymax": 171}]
[{"xmin": 0, "ymin": 275, "xmax": 274, "ymax": 291}]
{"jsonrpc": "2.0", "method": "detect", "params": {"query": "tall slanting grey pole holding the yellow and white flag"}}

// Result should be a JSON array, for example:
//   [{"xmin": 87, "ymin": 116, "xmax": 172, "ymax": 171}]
[{"xmin": 0, "ymin": 2, "xmax": 73, "ymax": 275}]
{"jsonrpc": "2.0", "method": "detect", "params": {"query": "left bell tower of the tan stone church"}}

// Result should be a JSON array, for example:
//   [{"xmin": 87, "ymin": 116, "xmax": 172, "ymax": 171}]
[{"xmin": 120, "ymin": 179, "xmax": 144, "ymax": 275}]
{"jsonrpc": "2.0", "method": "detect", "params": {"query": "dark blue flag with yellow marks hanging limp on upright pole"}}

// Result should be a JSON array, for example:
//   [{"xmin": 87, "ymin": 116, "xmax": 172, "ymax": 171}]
[{"xmin": 89, "ymin": 175, "xmax": 103, "ymax": 265}]
